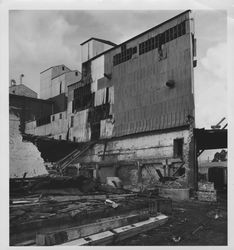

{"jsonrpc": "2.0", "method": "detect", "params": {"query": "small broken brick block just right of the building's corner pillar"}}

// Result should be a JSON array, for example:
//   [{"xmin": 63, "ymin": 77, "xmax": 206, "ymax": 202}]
[{"xmin": 197, "ymin": 182, "xmax": 217, "ymax": 202}]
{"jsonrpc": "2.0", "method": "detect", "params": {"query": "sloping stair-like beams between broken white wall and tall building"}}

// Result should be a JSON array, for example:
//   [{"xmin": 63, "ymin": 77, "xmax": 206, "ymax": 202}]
[{"xmin": 54, "ymin": 141, "xmax": 96, "ymax": 174}]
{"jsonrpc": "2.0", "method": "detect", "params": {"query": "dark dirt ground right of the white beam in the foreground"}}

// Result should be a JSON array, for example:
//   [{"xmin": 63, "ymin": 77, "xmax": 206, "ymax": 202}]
[{"xmin": 118, "ymin": 194, "xmax": 227, "ymax": 246}]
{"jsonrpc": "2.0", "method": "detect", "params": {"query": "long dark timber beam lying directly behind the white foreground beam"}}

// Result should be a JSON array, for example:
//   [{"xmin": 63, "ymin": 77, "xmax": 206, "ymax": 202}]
[{"xmin": 36, "ymin": 211, "xmax": 149, "ymax": 246}]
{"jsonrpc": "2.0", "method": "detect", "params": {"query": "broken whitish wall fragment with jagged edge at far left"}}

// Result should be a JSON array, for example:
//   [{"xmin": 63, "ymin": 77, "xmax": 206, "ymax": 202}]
[{"xmin": 9, "ymin": 113, "xmax": 47, "ymax": 178}]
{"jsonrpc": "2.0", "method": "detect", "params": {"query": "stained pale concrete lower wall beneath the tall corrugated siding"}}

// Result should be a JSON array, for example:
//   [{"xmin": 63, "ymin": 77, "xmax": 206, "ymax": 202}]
[{"xmin": 77, "ymin": 129, "xmax": 194, "ymax": 187}]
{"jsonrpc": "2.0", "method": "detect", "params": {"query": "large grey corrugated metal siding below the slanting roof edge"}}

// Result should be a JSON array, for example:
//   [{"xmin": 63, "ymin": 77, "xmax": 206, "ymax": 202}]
[{"xmin": 105, "ymin": 13, "xmax": 194, "ymax": 136}]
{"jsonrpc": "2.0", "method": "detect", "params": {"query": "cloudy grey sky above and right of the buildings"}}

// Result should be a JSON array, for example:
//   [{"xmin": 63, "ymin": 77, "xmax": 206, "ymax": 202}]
[{"xmin": 9, "ymin": 10, "xmax": 227, "ymax": 128}]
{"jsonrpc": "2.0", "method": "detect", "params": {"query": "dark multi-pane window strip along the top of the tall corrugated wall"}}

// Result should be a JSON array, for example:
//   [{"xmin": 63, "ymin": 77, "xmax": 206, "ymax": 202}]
[{"xmin": 113, "ymin": 21, "xmax": 186, "ymax": 66}]
